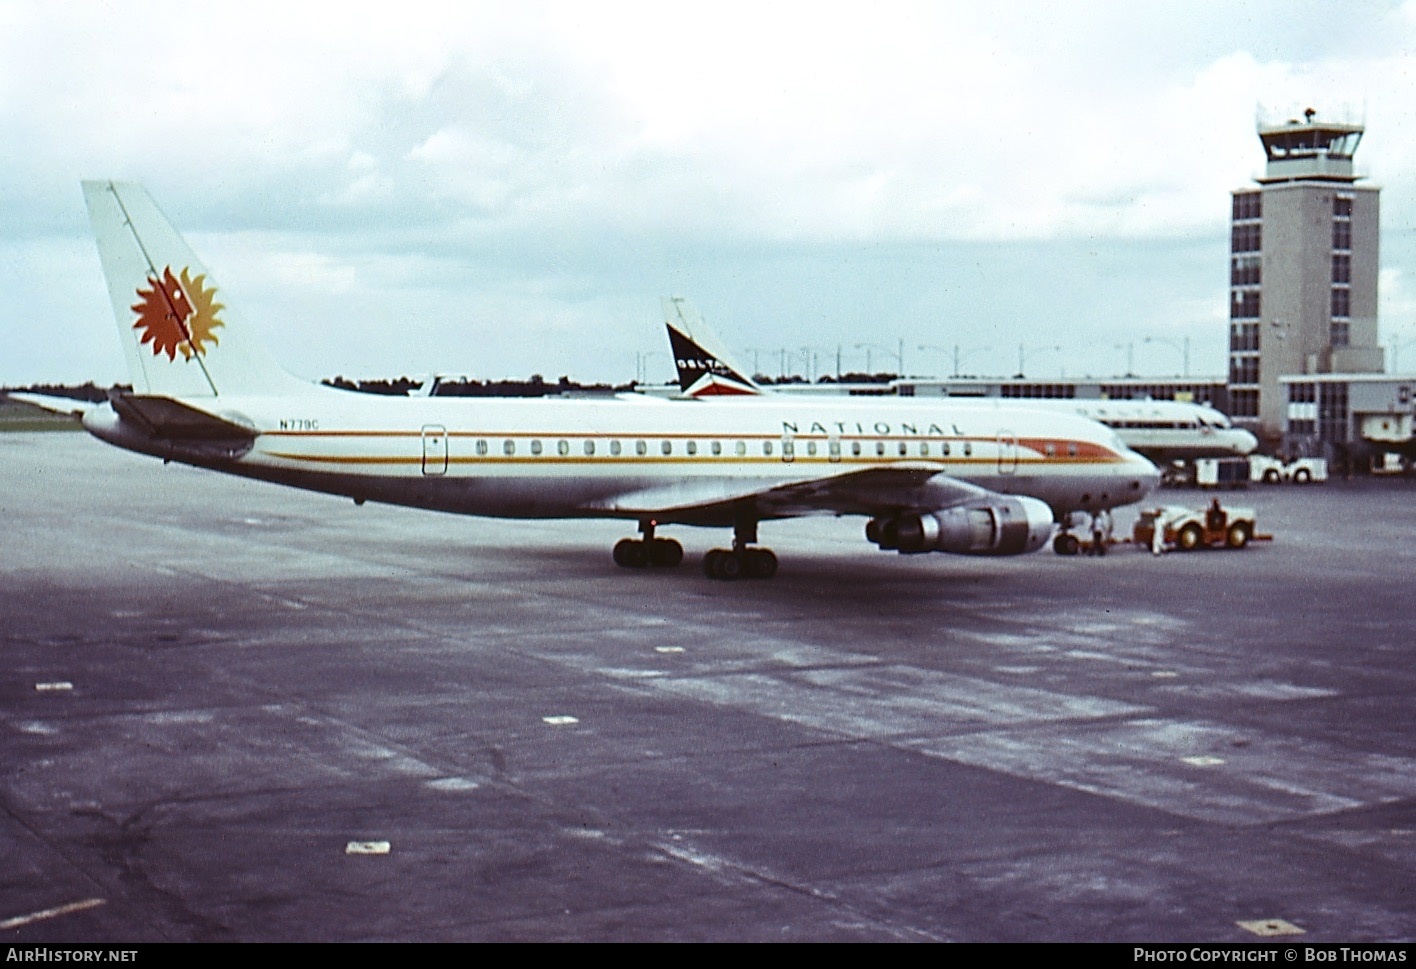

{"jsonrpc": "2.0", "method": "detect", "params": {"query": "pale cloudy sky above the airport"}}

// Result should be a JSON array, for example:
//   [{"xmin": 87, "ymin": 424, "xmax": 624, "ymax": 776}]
[{"xmin": 0, "ymin": 0, "xmax": 1416, "ymax": 385}]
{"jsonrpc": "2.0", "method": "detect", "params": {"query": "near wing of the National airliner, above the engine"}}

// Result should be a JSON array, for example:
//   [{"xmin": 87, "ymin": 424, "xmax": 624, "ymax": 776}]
[{"xmin": 586, "ymin": 462, "xmax": 998, "ymax": 524}]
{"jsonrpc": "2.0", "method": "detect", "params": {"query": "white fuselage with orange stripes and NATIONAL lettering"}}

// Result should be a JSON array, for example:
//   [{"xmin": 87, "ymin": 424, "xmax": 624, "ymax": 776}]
[{"xmin": 85, "ymin": 387, "xmax": 1158, "ymax": 524}]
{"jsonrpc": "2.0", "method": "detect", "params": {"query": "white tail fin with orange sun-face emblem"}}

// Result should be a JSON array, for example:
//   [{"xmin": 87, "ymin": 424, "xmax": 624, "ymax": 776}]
[{"xmin": 84, "ymin": 181, "xmax": 310, "ymax": 397}]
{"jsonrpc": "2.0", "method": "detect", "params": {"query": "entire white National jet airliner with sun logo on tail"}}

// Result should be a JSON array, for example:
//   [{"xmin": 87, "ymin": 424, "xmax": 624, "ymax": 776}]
[{"xmin": 58, "ymin": 181, "xmax": 1158, "ymax": 579}]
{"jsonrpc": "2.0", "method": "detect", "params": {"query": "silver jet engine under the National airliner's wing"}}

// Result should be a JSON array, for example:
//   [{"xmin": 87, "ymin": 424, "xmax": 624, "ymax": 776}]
[{"xmin": 865, "ymin": 496, "xmax": 1052, "ymax": 555}]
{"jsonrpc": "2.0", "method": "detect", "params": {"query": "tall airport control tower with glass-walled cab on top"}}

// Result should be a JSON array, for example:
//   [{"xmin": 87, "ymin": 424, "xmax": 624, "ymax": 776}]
[{"xmin": 1229, "ymin": 108, "xmax": 1383, "ymax": 439}]
